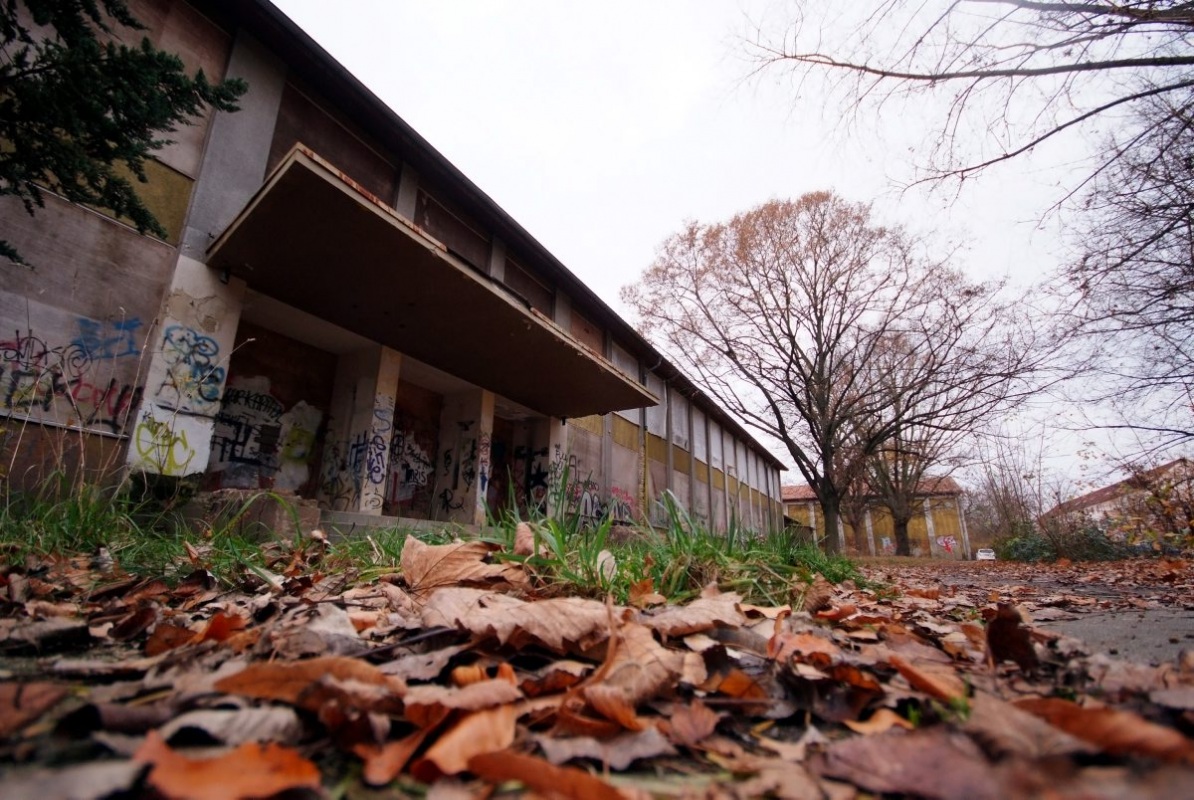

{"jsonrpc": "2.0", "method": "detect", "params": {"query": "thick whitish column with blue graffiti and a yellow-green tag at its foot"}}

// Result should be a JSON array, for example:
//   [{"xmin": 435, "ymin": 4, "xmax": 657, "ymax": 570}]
[{"xmin": 127, "ymin": 256, "xmax": 245, "ymax": 476}]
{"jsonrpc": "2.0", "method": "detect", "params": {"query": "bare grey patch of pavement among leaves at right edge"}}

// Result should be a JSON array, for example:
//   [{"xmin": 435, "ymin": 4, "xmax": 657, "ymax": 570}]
[{"xmin": 1033, "ymin": 608, "xmax": 1194, "ymax": 665}]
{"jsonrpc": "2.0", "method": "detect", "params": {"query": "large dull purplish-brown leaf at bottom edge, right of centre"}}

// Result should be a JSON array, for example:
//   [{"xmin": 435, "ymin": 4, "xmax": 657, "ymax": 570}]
[{"xmin": 813, "ymin": 727, "xmax": 1004, "ymax": 800}]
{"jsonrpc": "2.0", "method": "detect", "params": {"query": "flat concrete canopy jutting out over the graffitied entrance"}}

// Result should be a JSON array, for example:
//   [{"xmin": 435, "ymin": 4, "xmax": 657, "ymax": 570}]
[{"xmin": 208, "ymin": 146, "xmax": 659, "ymax": 417}]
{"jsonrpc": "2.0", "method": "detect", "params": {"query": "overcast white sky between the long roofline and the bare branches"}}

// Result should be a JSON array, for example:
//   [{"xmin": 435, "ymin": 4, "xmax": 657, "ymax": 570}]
[{"xmin": 266, "ymin": 0, "xmax": 1122, "ymax": 489}]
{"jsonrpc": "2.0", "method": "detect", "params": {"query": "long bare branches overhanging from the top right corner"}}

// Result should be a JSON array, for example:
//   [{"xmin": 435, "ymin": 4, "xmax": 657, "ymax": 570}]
[{"xmin": 755, "ymin": 0, "xmax": 1194, "ymax": 191}]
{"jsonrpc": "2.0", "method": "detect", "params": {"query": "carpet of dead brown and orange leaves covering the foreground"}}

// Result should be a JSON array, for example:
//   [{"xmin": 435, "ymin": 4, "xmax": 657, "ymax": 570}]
[{"xmin": 0, "ymin": 539, "xmax": 1194, "ymax": 800}]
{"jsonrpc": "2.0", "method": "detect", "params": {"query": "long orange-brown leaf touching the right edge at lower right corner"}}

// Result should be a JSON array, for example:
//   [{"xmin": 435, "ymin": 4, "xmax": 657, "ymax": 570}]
[{"xmin": 1015, "ymin": 697, "xmax": 1194, "ymax": 763}]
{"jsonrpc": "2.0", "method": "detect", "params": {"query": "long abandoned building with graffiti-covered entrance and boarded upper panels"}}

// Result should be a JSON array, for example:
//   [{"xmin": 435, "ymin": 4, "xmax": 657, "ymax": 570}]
[{"xmin": 0, "ymin": 0, "xmax": 783, "ymax": 539}]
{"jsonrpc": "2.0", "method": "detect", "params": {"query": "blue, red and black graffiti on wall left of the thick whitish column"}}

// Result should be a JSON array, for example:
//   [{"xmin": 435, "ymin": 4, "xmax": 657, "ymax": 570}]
[{"xmin": 0, "ymin": 316, "xmax": 144, "ymax": 433}]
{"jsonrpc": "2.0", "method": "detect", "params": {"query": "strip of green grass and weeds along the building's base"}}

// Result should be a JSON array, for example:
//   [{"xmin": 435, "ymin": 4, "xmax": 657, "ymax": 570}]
[{"xmin": 0, "ymin": 468, "xmax": 861, "ymax": 604}]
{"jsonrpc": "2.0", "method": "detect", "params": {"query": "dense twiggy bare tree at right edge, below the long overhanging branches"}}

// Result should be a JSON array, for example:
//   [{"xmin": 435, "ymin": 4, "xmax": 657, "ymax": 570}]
[{"xmin": 1064, "ymin": 97, "xmax": 1194, "ymax": 449}]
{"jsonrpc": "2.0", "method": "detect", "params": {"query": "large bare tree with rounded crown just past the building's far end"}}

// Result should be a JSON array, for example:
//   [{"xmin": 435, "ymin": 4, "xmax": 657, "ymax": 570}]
[{"xmin": 622, "ymin": 192, "xmax": 1035, "ymax": 552}]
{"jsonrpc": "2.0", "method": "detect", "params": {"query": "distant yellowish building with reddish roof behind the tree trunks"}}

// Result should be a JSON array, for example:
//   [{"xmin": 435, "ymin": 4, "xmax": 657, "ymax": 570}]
[{"xmin": 782, "ymin": 478, "xmax": 971, "ymax": 559}]
